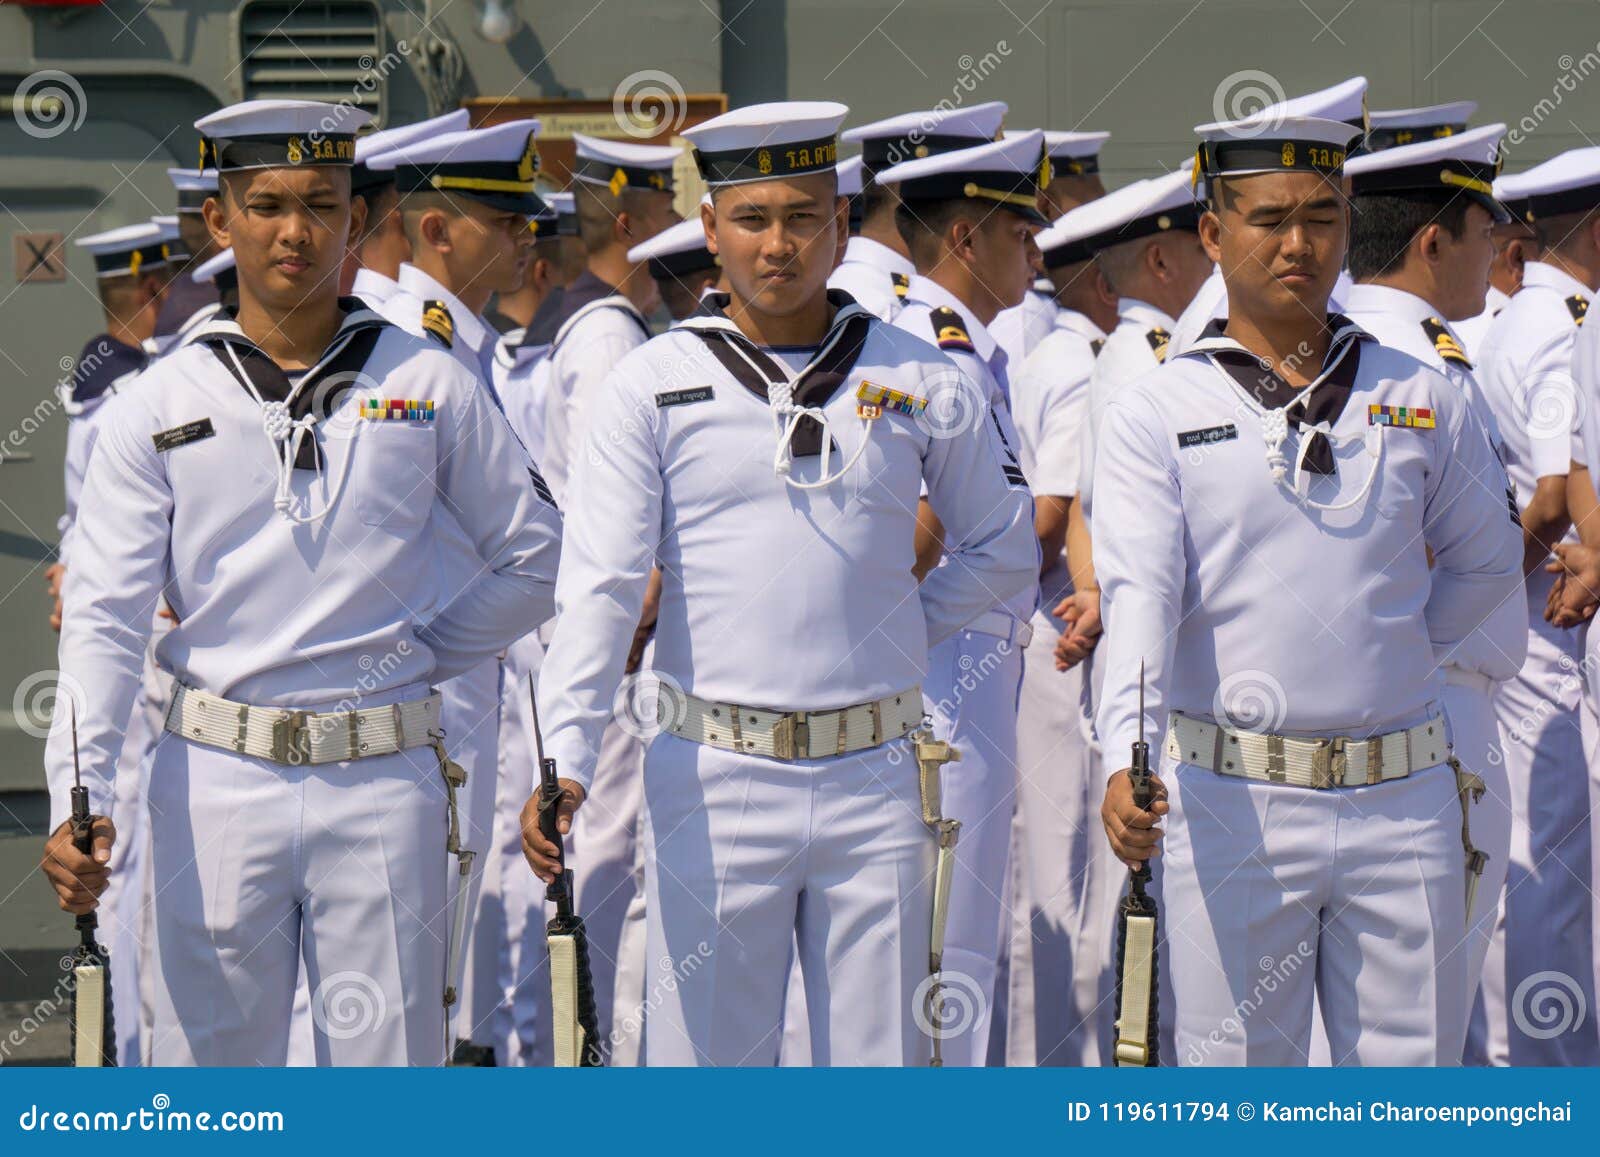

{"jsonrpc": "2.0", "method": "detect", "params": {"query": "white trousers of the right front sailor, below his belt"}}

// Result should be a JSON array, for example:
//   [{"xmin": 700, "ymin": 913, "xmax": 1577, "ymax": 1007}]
[{"xmin": 1160, "ymin": 759, "xmax": 1467, "ymax": 1066}]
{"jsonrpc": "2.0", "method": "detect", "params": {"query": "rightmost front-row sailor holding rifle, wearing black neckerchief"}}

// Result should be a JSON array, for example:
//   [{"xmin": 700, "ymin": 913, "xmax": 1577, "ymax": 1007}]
[{"xmin": 1094, "ymin": 117, "xmax": 1522, "ymax": 1066}]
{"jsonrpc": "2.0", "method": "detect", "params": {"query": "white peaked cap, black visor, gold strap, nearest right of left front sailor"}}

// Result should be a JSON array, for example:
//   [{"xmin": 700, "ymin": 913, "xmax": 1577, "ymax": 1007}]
[{"xmin": 366, "ymin": 120, "xmax": 544, "ymax": 216}]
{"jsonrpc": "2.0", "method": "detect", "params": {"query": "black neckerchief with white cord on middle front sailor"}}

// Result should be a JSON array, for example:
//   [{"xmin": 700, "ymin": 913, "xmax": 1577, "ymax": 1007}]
[{"xmin": 677, "ymin": 290, "xmax": 875, "ymax": 458}]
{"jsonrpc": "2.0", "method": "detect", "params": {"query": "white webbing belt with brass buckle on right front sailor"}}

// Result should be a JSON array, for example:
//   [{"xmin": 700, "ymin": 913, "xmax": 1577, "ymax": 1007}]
[{"xmin": 1166, "ymin": 712, "xmax": 1450, "ymax": 789}]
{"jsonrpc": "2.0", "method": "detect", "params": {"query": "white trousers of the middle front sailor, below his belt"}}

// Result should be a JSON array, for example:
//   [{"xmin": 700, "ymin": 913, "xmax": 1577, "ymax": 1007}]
[{"xmin": 645, "ymin": 735, "xmax": 934, "ymax": 1066}]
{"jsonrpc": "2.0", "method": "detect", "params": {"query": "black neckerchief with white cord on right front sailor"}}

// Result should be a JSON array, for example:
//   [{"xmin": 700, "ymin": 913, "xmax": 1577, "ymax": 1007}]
[{"xmin": 1184, "ymin": 314, "xmax": 1373, "ymax": 474}]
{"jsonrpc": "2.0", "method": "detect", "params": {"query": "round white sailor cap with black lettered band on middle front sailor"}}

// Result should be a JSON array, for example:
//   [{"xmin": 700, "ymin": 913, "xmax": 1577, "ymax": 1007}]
[{"xmin": 683, "ymin": 101, "xmax": 850, "ymax": 189}]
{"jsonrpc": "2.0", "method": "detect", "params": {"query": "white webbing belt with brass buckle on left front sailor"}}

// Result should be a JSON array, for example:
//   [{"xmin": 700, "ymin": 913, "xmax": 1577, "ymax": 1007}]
[{"xmin": 165, "ymin": 683, "xmax": 438, "ymax": 765}]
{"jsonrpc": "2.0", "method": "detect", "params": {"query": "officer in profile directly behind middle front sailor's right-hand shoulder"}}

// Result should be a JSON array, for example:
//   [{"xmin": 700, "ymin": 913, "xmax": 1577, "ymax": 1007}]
[{"xmin": 878, "ymin": 131, "xmax": 1050, "ymax": 1066}]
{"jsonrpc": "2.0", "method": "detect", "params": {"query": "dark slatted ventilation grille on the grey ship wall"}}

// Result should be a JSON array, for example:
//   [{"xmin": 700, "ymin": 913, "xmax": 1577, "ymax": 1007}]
[{"xmin": 238, "ymin": 0, "xmax": 390, "ymax": 122}]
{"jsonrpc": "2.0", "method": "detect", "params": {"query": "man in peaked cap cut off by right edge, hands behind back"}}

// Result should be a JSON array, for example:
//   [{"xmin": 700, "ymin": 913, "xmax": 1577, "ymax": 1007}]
[{"xmin": 1469, "ymin": 147, "xmax": 1600, "ymax": 1064}]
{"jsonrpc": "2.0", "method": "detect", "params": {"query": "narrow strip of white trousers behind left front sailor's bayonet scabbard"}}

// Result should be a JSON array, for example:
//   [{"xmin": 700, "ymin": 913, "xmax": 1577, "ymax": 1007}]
[{"xmin": 438, "ymin": 658, "xmax": 501, "ymax": 1045}]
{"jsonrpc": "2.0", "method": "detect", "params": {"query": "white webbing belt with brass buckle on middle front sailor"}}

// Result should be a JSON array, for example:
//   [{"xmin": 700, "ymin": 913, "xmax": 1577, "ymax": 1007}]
[{"xmin": 656, "ymin": 683, "xmax": 922, "ymax": 760}]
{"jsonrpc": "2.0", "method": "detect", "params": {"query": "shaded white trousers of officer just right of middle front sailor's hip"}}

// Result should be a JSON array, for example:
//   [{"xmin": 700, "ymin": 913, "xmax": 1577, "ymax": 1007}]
[{"xmin": 922, "ymin": 631, "xmax": 1022, "ymax": 1066}]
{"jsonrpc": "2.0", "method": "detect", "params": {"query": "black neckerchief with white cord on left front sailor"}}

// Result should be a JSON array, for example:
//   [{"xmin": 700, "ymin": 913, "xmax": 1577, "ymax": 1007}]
[{"xmin": 195, "ymin": 298, "xmax": 389, "ymax": 470}]
